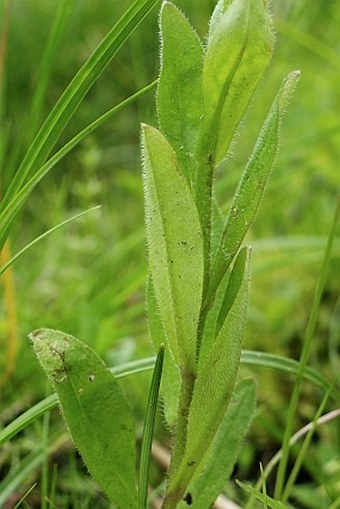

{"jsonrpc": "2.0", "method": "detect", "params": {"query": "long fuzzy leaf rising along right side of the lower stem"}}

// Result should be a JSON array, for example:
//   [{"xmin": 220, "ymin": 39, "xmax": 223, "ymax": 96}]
[{"xmin": 169, "ymin": 248, "xmax": 249, "ymax": 494}]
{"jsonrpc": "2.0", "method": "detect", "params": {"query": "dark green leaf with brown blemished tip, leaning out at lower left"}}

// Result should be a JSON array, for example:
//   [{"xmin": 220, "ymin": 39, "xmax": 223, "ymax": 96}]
[{"xmin": 29, "ymin": 329, "xmax": 137, "ymax": 509}]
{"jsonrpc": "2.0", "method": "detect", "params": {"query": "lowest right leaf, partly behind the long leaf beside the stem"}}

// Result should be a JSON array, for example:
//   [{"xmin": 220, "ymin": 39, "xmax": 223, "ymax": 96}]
[{"xmin": 178, "ymin": 379, "xmax": 256, "ymax": 509}]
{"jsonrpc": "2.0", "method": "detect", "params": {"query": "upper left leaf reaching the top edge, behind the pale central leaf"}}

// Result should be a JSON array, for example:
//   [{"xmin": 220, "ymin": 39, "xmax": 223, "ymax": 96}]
[{"xmin": 157, "ymin": 2, "xmax": 203, "ymax": 180}]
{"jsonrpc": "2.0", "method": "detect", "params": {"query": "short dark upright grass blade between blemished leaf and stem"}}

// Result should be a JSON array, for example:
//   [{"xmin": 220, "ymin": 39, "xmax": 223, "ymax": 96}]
[{"xmin": 139, "ymin": 345, "xmax": 164, "ymax": 509}]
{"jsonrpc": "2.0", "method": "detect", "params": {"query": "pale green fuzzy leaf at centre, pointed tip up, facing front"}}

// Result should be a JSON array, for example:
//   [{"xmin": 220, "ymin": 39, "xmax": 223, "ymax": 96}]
[{"xmin": 142, "ymin": 125, "xmax": 203, "ymax": 373}]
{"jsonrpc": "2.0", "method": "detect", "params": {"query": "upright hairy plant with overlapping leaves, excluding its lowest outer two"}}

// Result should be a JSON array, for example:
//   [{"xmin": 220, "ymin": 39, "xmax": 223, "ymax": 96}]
[{"xmin": 142, "ymin": 0, "xmax": 298, "ymax": 509}]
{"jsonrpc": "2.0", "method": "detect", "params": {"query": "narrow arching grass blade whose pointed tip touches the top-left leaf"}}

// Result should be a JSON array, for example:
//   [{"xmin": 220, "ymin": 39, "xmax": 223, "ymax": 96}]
[{"xmin": 0, "ymin": 80, "xmax": 157, "ymax": 244}]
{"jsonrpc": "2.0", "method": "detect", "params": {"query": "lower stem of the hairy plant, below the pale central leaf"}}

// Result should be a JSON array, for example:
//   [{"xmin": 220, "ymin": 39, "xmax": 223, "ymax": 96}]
[{"xmin": 163, "ymin": 372, "xmax": 195, "ymax": 509}]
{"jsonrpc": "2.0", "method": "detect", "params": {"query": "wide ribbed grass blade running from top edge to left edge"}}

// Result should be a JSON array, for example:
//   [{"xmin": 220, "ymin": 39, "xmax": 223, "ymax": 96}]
[{"xmin": 0, "ymin": 0, "xmax": 158, "ymax": 242}]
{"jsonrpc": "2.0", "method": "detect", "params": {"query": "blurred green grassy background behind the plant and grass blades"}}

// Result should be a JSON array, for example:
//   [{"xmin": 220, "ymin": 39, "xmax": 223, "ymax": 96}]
[{"xmin": 0, "ymin": 0, "xmax": 340, "ymax": 508}]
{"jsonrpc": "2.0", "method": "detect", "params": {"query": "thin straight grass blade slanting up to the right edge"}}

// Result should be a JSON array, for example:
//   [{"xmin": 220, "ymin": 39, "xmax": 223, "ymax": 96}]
[{"xmin": 274, "ymin": 201, "xmax": 340, "ymax": 499}]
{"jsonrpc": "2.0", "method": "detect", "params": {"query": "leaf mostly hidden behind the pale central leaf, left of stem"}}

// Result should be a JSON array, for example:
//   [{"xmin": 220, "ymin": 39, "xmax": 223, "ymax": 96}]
[{"xmin": 147, "ymin": 278, "xmax": 181, "ymax": 428}]
